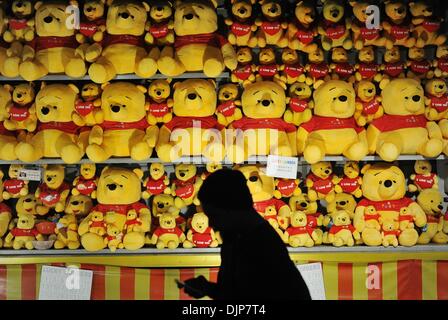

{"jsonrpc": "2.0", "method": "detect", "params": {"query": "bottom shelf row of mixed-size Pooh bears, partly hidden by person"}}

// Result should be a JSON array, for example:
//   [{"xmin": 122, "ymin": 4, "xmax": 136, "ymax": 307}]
[{"xmin": 0, "ymin": 161, "xmax": 448, "ymax": 251}]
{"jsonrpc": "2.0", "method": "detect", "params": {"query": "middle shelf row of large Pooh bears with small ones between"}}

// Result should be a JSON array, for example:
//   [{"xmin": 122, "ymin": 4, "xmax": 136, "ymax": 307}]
[{"xmin": 0, "ymin": 78, "xmax": 448, "ymax": 163}]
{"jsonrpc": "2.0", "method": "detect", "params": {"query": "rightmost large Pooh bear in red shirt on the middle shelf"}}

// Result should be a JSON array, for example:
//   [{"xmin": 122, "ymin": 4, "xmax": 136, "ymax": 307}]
[{"xmin": 367, "ymin": 79, "xmax": 443, "ymax": 161}]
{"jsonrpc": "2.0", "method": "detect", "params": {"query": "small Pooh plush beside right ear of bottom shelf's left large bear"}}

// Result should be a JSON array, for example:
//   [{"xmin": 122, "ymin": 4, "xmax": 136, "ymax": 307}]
[{"xmin": 142, "ymin": 162, "xmax": 171, "ymax": 200}]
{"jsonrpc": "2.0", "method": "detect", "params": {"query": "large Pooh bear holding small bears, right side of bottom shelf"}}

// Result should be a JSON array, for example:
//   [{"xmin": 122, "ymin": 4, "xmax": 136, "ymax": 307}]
[{"xmin": 353, "ymin": 163, "xmax": 426, "ymax": 246}]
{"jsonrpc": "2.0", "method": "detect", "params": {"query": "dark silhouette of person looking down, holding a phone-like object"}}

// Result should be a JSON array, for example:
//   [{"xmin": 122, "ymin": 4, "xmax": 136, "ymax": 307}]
[{"xmin": 179, "ymin": 169, "xmax": 310, "ymax": 300}]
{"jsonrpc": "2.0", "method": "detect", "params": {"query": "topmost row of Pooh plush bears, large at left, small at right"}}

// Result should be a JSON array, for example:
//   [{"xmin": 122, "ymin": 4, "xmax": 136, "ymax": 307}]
[{"xmin": 0, "ymin": 0, "xmax": 446, "ymax": 83}]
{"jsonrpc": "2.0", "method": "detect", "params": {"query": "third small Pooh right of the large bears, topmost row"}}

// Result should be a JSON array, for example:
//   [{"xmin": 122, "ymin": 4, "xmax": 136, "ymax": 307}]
[{"xmin": 288, "ymin": 0, "xmax": 318, "ymax": 53}]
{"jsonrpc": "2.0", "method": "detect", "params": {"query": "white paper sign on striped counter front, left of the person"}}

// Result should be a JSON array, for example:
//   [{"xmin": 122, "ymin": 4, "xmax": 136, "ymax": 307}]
[{"xmin": 39, "ymin": 266, "xmax": 93, "ymax": 300}]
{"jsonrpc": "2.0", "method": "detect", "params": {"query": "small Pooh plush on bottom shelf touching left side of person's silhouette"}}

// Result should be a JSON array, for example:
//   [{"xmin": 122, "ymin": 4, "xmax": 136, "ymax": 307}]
[{"xmin": 183, "ymin": 212, "xmax": 218, "ymax": 248}]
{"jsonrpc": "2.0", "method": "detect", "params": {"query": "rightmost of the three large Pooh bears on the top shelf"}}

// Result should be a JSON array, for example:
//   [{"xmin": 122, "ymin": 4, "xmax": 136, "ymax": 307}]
[{"xmin": 157, "ymin": 0, "xmax": 237, "ymax": 78}]
